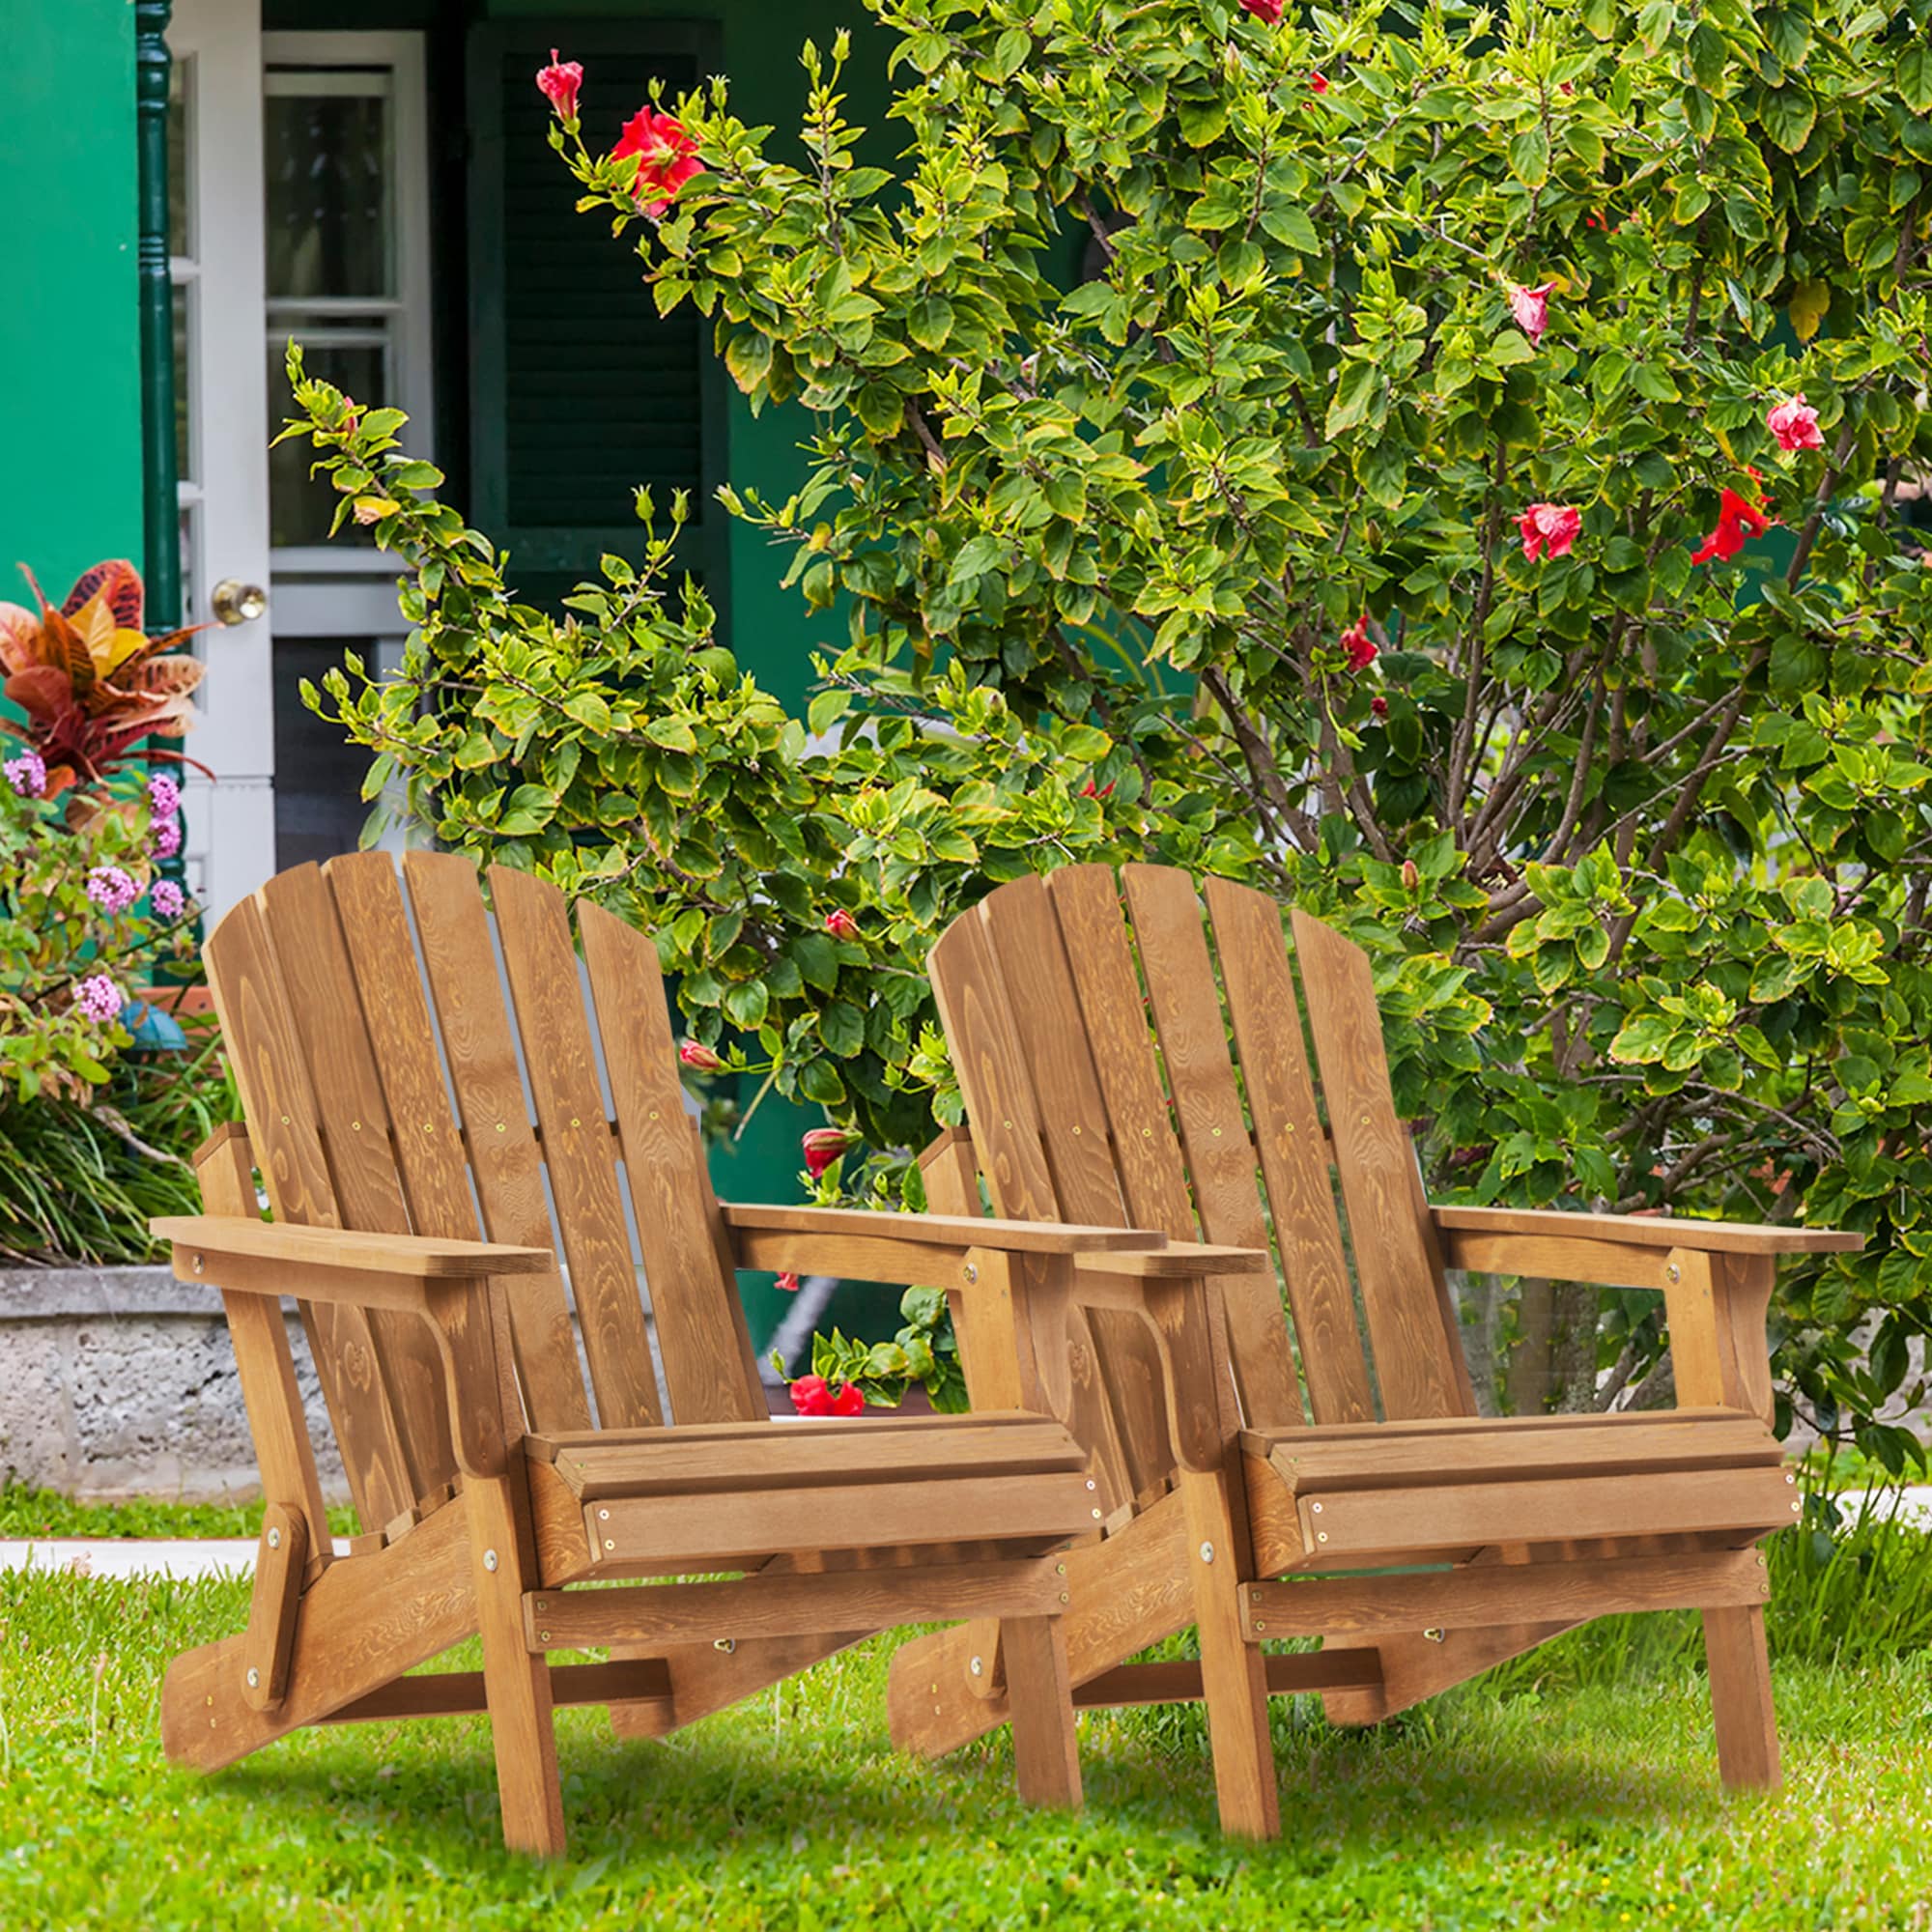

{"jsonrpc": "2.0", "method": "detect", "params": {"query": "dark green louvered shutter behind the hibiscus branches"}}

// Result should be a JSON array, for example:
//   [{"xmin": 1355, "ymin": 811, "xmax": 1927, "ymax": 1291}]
[{"xmin": 468, "ymin": 19, "xmax": 724, "ymax": 618}]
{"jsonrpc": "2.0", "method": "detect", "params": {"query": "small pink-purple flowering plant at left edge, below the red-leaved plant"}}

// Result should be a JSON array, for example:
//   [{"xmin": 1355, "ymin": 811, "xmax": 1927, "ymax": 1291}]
[{"xmin": 0, "ymin": 769, "xmax": 193, "ymax": 1105}]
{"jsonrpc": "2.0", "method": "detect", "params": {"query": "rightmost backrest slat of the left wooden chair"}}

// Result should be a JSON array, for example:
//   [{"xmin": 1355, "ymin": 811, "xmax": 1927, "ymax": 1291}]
[{"xmin": 578, "ymin": 902, "xmax": 767, "ymax": 1422}]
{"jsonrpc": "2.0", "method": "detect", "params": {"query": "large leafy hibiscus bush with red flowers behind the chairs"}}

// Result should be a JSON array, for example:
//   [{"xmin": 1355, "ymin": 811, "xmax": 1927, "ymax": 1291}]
[{"xmin": 307, "ymin": 0, "xmax": 1932, "ymax": 1461}]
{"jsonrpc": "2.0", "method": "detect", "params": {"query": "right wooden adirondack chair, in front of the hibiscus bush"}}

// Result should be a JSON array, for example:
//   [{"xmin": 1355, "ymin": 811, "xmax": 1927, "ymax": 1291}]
[{"xmin": 891, "ymin": 866, "xmax": 1861, "ymax": 1835}]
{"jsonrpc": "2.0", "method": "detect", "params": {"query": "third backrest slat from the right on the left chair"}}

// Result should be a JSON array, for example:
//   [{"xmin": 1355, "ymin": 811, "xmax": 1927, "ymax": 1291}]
[{"xmin": 396, "ymin": 852, "xmax": 591, "ymax": 1432}]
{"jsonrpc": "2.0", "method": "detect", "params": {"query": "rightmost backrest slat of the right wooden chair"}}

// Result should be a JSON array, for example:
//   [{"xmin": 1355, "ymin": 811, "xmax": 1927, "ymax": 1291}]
[{"xmin": 1293, "ymin": 910, "xmax": 1463, "ymax": 1422}]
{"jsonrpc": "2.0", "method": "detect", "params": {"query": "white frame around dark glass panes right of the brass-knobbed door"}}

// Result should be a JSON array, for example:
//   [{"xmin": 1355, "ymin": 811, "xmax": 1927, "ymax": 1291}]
[{"xmin": 261, "ymin": 33, "xmax": 437, "ymax": 580}]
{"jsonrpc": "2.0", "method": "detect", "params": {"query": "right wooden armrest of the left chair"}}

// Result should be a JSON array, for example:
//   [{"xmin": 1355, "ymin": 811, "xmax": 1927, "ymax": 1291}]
[{"xmin": 719, "ymin": 1202, "xmax": 1167, "ymax": 1289}]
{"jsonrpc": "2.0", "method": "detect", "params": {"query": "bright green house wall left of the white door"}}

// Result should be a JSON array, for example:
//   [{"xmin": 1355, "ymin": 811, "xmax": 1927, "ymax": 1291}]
[{"xmin": 0, "ymin": 0, "xmax": 141, "ymax": 603}]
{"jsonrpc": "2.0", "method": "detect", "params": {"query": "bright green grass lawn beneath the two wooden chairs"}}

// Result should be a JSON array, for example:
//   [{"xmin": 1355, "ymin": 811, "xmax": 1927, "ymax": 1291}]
[{"xmin": 0, "ymin": 1538, "xmax": 1932, "ymax": 1932}]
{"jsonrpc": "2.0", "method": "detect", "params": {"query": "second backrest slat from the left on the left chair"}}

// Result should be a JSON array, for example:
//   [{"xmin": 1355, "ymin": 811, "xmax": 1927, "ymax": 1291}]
[{"xmin": 261, "ymin": 866, "xmax": 462, "ymax": 1501}]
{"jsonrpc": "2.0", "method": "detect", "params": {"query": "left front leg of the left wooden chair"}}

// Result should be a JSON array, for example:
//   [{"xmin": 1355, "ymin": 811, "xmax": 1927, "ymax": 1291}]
[{"xmin": 464, "ymin": 1466, "xmax": 564, "ymax": 1859}]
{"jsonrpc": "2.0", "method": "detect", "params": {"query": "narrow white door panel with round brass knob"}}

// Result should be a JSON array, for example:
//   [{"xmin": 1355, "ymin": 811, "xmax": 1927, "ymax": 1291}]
[{"xmin": 168, "ymin": 0, "xmax": 274, "ymax": 918}]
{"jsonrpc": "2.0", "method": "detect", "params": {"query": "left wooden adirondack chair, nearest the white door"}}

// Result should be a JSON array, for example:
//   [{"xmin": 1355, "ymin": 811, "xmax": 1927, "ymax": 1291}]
[{"xmin": 143, "ymin": 854, "xmax": 1190, "ymax": 1853}]
